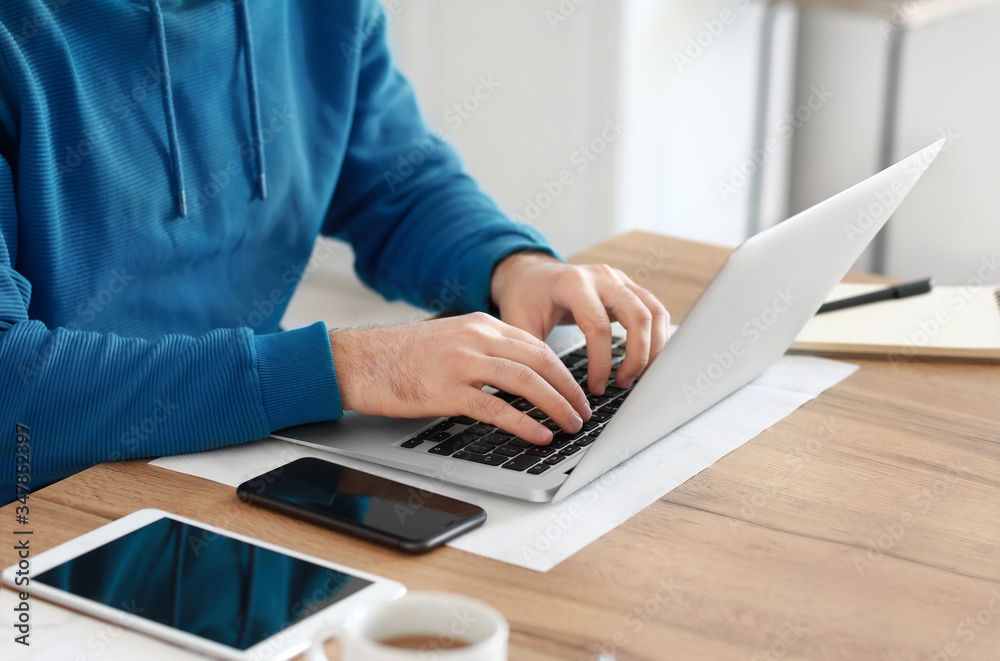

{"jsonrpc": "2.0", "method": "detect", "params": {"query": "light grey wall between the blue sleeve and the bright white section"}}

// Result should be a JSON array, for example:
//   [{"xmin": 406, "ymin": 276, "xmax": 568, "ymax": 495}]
[{"xmin": 390, "ymin": 0, "xmax": 621, "ymax": 254}]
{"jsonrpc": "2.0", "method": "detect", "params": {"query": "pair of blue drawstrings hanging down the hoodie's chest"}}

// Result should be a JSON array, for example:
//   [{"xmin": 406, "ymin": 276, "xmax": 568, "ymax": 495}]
[{"xmin": 148, "ymin": 0, "xmax": 267, "ymax": 218}]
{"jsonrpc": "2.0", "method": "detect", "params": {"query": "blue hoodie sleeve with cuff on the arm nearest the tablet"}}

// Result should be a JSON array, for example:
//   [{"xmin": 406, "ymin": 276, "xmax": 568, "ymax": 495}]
[{"xmin": 0, "ymin": 156, "xmax": 342, "ymax": 504}]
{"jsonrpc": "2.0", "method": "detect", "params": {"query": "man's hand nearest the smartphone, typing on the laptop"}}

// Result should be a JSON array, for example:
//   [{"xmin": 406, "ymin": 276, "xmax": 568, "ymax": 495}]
[{"xmin": 330, "ymin": 312, "xmax": 590, "ymax": 444}]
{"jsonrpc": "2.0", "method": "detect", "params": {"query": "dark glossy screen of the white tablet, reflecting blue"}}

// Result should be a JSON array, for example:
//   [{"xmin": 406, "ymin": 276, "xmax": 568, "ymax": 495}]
[{"xmin": 32, "ymin": 518, "xmax": 371, "ymax": 650}]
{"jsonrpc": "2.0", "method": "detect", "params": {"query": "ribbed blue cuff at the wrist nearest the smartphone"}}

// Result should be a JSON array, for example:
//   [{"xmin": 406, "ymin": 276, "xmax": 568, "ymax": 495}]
[{"xmin": 253, "ymin": 321, "xmax": 344, "ymax": 431}]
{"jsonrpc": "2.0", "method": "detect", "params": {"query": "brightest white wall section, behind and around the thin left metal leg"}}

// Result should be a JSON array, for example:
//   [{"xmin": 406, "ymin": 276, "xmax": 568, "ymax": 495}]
[{"xmin": 617, "ymin": 0, "xmax": 794, "ymax": 245}]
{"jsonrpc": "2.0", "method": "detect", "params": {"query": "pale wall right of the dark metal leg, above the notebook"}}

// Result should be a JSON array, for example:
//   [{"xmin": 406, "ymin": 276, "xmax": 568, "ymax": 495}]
[{"xmin": 887, "ymin": 3, "xmax": 1000, "ymax": 284}]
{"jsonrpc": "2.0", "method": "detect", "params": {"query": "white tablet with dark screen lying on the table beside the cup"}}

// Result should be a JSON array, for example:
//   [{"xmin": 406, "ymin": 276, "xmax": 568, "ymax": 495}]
[{"xmin": 3, "ymin": 509, "xmax": 406, "ymax": 661}]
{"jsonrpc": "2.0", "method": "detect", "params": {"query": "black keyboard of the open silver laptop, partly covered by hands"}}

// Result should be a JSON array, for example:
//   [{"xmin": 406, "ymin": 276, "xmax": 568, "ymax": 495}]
[{"xmin": 400, "ymin": 337, "xmax": 638, "ymax": 475}]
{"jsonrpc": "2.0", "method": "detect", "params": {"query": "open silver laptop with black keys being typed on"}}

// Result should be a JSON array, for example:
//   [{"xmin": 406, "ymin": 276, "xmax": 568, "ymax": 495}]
[{"xmin": 273, "ymin": 139, "xmax": 944, "ymax": 502}]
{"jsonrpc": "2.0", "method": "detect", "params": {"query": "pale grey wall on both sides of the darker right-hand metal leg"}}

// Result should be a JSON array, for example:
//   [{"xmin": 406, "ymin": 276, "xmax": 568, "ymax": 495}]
[{"xmin": 791, "ymin": 3, "xmax": 1000, "ymax": 284}]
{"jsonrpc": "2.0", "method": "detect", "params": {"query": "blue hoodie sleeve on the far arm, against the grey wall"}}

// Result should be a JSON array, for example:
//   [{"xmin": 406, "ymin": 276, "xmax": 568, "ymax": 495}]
[{"xmin": 324, "ymin": 0, "xmax": 558, "ymax": 312}]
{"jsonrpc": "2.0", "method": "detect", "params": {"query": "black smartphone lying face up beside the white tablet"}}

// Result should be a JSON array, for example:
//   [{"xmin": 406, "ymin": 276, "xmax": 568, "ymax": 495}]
[{"xmin": 236, "ymin": 457, "xmax": 486, "ymax": 553}]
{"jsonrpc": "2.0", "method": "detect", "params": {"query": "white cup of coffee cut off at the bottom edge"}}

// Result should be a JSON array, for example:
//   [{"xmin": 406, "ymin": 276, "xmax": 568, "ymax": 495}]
[{"xmin": 309, "ymin": 592, "xmax": 510, "ymax": 661}]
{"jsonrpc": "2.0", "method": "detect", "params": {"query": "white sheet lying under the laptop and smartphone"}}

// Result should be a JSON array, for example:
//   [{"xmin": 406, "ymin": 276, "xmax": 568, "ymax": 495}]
[{"xmin": 151, "ymin": 356, "xmax": 857, "ymax": 572}]
